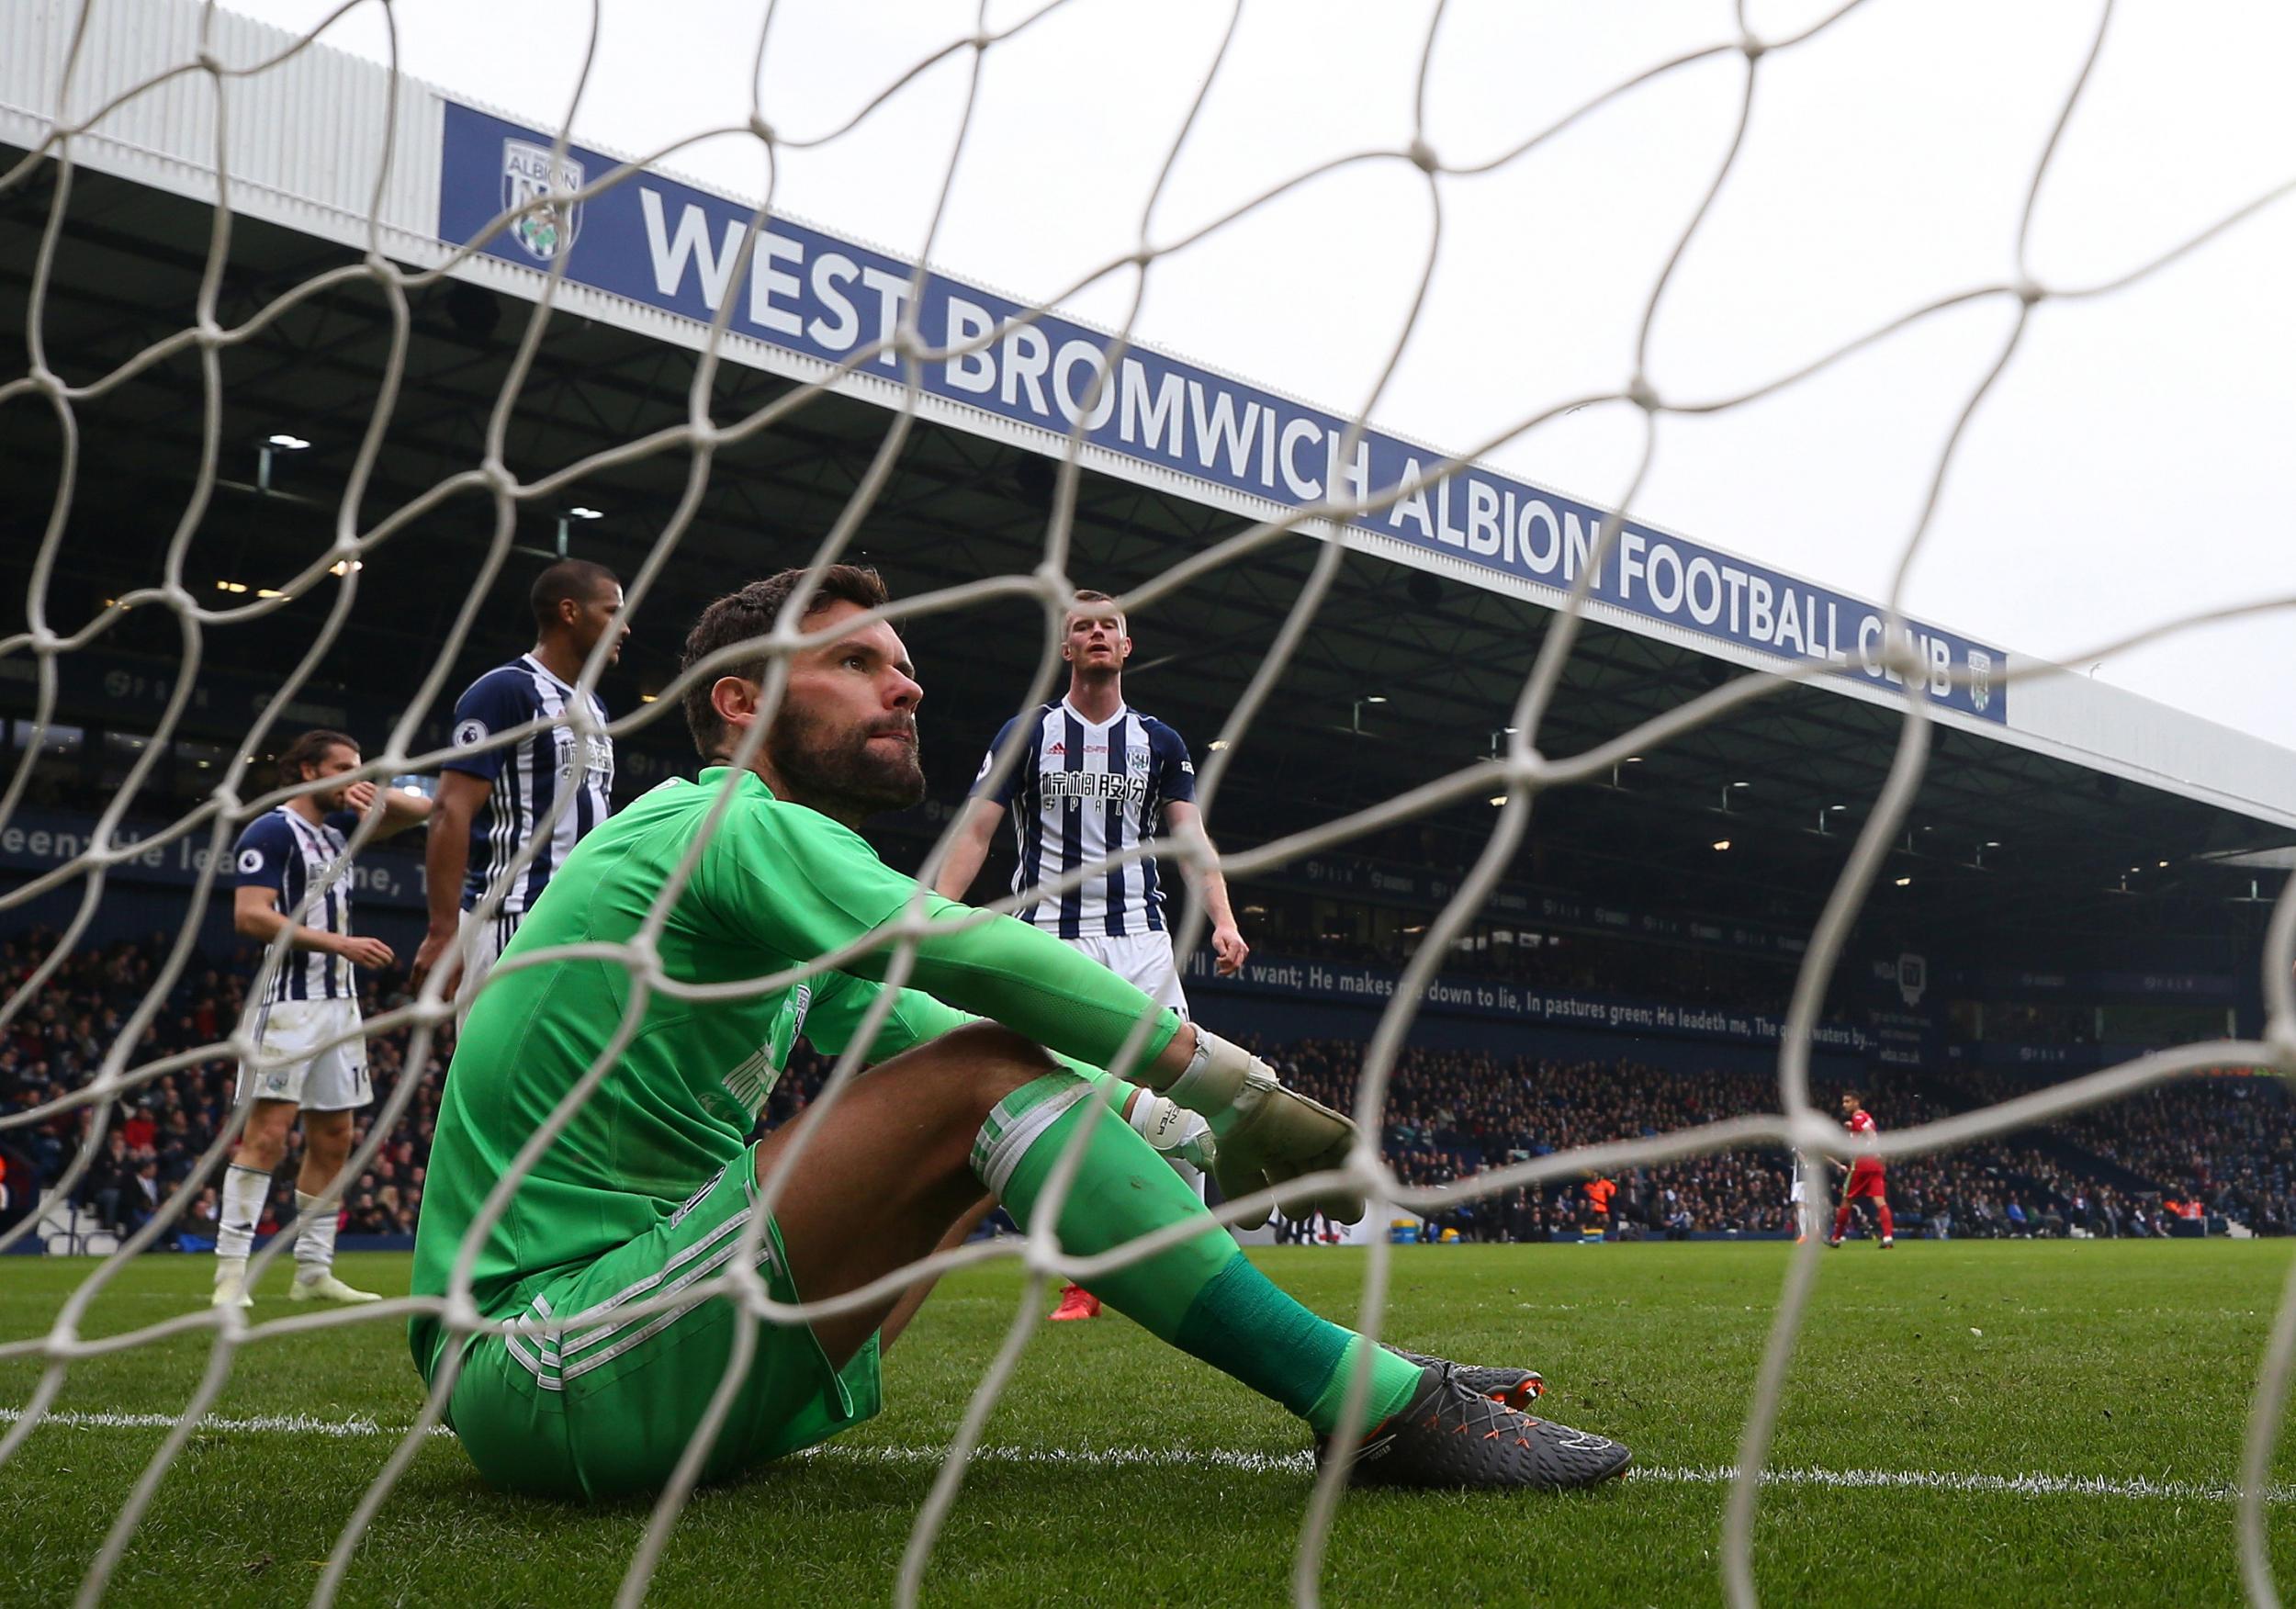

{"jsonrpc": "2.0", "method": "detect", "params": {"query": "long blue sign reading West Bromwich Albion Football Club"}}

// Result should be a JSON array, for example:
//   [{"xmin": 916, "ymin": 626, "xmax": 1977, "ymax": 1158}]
[{"xmin": 439, "ymin": 101, "xmax": 2009, "ymax": 726}]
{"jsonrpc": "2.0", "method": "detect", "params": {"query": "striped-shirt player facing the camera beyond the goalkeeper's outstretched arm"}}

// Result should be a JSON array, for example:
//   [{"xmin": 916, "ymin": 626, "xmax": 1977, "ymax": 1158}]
[{"xmin": 935, "ymin": 592, "xmax": 1252, "ymax": 1322}]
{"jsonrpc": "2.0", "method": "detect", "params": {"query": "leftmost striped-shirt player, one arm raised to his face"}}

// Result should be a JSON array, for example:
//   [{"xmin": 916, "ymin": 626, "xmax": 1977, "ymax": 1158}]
[{"xmin": 214, "ymin": 730, "xmax": 432, "ymax": 1309}]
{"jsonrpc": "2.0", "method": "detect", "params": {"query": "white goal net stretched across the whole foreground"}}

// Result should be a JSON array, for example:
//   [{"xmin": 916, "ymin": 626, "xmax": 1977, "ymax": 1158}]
[{"xmin": 0, "ymin": 0, "xmax": 2296, "ymax": 1604}]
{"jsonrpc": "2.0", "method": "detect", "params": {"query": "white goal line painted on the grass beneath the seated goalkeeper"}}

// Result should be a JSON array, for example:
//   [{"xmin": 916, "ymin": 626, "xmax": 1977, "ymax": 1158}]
[{"xmin": 0, "ymin": 1407, "xmax": 2296, "ymax": 1503}]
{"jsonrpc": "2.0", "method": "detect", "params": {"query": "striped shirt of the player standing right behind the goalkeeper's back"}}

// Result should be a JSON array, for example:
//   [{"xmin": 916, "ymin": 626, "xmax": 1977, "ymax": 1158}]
[{"xmin": 444, "ymin": 654, "xmax": 613, "ymax": 918}]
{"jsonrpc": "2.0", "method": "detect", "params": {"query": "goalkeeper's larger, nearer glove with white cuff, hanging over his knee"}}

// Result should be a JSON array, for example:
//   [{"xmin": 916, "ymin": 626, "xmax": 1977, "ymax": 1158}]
[{"xmin": 1165, "ymin": 1029, "xmax": 1364, "ymax": 1228}]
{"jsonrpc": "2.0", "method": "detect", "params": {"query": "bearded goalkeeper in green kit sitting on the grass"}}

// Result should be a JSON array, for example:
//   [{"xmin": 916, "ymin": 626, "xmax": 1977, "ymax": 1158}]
[{"xmin": 409, "ymin": 565, "xmax": 1628, "ymax": 1499}]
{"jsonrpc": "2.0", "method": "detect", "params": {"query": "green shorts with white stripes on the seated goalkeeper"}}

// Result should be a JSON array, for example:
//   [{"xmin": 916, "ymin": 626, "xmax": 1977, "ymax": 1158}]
[{"xmin": 448, "ymin": 1153, "xmax": 884, "ymax": 1502}]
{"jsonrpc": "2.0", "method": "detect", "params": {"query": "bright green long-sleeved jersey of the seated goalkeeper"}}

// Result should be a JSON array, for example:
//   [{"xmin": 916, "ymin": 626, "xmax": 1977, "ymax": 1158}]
[{"xmin": 409, "ymin": 767, "xmax": 1180, "ymax": 1379}]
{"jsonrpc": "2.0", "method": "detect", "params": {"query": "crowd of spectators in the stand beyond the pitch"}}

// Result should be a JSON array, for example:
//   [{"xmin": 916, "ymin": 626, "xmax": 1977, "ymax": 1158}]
[{"xmin": 0, "ymin": 934, "xmax": 2296, "ymax": 1244}]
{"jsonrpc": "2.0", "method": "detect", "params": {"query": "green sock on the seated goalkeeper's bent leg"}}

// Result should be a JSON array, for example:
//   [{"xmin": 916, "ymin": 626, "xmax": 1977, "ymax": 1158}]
[{"xmin": 974, "ymin": 1072, "xmax": 1419, "ymax": 1435}]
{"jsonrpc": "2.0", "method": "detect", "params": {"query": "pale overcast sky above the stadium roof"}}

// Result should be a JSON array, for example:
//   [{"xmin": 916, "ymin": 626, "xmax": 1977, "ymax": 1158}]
[{"xmin": 207, "ymin": 0, "xmax": 2296, "ymax": 746}]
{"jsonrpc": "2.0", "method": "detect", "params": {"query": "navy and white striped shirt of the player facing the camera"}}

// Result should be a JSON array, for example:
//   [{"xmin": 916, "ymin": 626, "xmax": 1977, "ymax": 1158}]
[{"xmin": 974, "ymin": 698, "xmax": 1197, "ymax": 939}]
